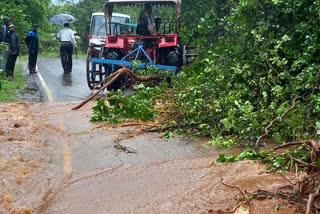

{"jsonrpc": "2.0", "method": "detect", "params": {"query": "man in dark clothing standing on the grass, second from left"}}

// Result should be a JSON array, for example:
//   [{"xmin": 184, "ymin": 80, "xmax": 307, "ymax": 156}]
[{"xmin": 6, "ymin": 24, "xmax": 21, "ymax": 81}]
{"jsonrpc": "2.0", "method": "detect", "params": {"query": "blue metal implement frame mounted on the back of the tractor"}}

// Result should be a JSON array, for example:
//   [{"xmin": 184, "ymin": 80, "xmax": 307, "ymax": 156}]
[{"xmin": 91, "ymin": 44, "xmax": 178, "ymax": 77}]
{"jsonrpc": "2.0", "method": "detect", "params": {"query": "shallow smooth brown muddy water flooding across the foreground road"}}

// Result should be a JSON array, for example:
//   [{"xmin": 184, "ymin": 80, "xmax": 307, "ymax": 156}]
[{"xmin": 0, "ymin": 103, "xmax": 293, "ymax": 214}]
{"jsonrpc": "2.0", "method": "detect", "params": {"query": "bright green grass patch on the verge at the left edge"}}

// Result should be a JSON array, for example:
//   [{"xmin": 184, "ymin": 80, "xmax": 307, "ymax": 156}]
[{"xmin": 0, "ymin": 63, "xmax": 25, "ymax": 102}]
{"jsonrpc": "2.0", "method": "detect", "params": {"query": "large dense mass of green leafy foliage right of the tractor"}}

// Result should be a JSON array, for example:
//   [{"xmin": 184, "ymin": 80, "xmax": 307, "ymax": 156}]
[{"xmin": 89, "ymin": 0, "xmax": 320, "ymax": 154}]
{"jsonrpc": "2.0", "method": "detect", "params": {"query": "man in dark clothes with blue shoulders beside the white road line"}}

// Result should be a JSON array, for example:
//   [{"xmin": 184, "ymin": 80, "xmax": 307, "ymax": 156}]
[{"xmin": 26, "ymin": 24, "xmax": 39, "ymax": 74}]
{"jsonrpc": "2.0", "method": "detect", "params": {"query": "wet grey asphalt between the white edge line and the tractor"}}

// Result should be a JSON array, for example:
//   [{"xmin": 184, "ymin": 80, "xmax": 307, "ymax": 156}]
[{"xmin": 38, "ymin": 58, "xmax": 91, "ymax": 102}]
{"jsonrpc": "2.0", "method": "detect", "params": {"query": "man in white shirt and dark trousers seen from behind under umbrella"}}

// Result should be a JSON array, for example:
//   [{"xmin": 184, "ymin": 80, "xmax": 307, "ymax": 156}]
[{"xmin": 57, "ymin": 23, "xmax": 77, "ymax": 74}]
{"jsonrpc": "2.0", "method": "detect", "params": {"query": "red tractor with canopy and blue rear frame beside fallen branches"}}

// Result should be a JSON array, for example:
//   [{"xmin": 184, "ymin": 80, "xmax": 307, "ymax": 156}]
[{"xmin": 87, "ymin": 0, "xmax": 195, "ymax": 90}]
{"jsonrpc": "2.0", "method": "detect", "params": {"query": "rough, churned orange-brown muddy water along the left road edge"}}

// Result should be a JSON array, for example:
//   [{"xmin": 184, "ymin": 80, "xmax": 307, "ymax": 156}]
[{"xmin": 0, "ymin": 103, "xmax": 63, "ymax": 214}]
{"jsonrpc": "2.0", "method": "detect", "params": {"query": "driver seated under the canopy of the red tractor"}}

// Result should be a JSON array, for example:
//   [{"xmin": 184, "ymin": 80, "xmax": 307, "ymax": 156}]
[{"xmin": 137, "ymin": 4, "xmax": 154, "ymax": 36}]
